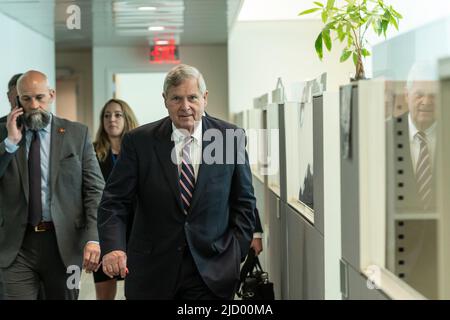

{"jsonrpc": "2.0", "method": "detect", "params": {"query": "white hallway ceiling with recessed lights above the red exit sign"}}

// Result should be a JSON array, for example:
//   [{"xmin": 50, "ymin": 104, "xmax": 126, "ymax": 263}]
[{"xmin": 0, "ymin": 0, "xmax": 243, "ymax": 48}]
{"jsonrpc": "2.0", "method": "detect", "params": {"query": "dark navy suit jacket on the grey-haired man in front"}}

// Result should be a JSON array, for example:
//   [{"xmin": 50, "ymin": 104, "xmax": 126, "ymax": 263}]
[{"xmin": 98, "ymin": 117, "xmax": 255, "ymax": 299}]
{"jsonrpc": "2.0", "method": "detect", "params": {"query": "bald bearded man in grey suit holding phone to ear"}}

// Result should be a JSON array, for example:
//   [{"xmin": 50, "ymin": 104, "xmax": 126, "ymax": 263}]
[{"xmin": 0, "ymin": 71, "xmax": 104, "ymax": 299}]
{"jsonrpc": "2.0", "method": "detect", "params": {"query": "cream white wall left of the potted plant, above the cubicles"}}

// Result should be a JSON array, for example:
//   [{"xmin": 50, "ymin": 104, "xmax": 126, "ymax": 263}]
[{"xmin": 228, "ymin": 20, "xmax": 354, "ymax": 113}]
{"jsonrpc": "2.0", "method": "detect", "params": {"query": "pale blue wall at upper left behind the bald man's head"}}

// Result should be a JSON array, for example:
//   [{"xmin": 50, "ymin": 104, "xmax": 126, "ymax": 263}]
[{"xmin": 0, "ymin": 12, "xmax": 55, "ymax": 115}]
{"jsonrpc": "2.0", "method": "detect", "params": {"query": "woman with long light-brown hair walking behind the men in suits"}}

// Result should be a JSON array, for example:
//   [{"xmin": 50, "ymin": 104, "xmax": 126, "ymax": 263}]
[{"xmin": 94, "ymin": 99, "xmax": 138, "ymax": 300}]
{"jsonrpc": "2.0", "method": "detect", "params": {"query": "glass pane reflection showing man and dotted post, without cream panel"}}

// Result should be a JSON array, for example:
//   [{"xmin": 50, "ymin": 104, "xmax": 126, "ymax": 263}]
[{"xmin": 385, "ymin": 77, "xmax": 439, "ymax": 299}]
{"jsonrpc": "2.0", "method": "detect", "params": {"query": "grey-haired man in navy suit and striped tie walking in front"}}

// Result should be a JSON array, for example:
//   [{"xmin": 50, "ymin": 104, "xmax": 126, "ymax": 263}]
[{"xmin": 98, "ymin": 65, "xmax": 255, "ymax": 299}]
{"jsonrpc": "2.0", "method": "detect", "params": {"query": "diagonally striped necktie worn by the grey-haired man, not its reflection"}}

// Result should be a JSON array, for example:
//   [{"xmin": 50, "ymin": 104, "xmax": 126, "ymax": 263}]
[{"xmin": 180, "ymin": 137, "xmax": 195, "ymax": 214}]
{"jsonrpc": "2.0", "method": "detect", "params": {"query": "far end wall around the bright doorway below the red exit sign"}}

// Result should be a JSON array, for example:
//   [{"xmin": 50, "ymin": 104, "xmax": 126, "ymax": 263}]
[{"xmin": 93, "ymin": 45, "xmax": 228, "ymax": 131}]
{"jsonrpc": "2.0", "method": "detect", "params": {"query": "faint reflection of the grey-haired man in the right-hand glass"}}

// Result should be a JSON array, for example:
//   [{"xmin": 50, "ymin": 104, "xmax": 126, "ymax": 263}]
[{"xmin": 390, "ymin": 81, "xmax": 437, "ymax": 212}]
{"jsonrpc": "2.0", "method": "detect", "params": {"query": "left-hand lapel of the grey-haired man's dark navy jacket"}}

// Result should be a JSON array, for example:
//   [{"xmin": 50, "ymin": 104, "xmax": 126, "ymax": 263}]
[{"xmin": 154, "ymin": 118, "xmax": 183, "ymax": 211}]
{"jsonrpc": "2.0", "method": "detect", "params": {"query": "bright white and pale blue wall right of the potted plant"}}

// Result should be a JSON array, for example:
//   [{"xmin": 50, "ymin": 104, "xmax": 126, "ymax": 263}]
[{"xmin": 369, "ymin": 0, "xmax": 450, "ymax": 80}]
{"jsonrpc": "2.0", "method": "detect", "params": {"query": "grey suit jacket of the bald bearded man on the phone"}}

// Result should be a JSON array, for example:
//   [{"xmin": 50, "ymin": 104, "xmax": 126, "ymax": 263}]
[{"xmin": 0, "ymin": 116, "xmax": 104, "ymax": 268}]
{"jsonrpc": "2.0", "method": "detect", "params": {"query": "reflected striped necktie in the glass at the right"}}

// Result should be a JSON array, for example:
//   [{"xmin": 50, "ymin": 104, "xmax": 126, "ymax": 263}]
[{"xmin": 416, "ymin": 131, "xmax": 433, "ymax": 210}]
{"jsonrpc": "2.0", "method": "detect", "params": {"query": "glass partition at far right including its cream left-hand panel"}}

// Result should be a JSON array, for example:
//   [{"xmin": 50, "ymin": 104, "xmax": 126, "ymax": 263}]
[{"xmin": 351, "ymin": 77, "xmax": 450, "ymax": 299}]
